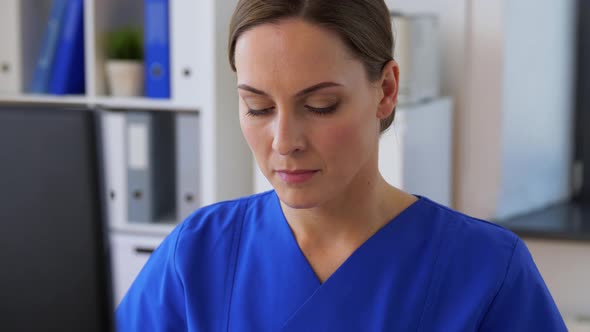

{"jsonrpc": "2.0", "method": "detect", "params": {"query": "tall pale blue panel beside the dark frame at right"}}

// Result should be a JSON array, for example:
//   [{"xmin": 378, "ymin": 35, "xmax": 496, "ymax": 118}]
[{"xmin": 496, "ymin": 0, "xmax": 575, "ymax": 219}]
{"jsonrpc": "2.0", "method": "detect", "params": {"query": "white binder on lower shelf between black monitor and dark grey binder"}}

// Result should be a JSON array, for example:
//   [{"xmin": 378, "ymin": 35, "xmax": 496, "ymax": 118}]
[{"xmin": 101, "ymin": 111, "xmax": 127, "ymax": 228}]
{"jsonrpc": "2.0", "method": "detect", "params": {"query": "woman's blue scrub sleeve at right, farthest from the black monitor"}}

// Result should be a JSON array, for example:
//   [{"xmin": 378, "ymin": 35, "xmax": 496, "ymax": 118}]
[{"xmin": 479, "ymin": 239, "xmax": 567, "ymax": 332}]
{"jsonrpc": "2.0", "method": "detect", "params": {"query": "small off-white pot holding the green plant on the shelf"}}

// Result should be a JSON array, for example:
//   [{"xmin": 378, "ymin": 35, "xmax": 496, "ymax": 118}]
[{"xmin": 106, "ymin": 60, "xmax": 144, "ymax": 97}]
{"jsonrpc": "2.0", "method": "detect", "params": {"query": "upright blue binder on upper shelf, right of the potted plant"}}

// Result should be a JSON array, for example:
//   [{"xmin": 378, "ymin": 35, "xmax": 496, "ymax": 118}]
[{"xmin": 144, "ymin": 0, "xmax": 170, "ymax": 98}]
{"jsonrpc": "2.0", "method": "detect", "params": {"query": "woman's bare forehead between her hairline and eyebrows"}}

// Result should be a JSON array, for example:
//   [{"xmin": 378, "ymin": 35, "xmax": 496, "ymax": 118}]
[{"xmin": 235, "ymin": 19, "xmax": 363, "ymax": 90}]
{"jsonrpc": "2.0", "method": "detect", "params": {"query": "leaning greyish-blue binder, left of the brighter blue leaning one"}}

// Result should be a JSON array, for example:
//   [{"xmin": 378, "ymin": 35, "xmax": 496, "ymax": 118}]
[{"xmin": 31, "ymin": 0, "xmax": 67, "ymax": 93}]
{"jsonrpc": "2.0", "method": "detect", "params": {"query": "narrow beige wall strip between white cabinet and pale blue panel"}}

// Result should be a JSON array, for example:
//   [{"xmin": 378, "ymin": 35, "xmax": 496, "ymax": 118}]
[{"xmin": 455, "ymin": 1, "xmax": 504, "ymax": 219}]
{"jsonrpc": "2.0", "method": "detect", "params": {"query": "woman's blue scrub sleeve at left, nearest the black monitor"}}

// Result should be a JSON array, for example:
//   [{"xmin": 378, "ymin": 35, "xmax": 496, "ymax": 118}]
[{"xmin": 115, "ymin": 224, "xmax": 186, "ymax": 332}]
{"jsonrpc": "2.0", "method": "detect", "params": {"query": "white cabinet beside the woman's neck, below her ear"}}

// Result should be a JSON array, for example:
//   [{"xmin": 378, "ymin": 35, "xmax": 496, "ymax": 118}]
[{"xmin": 379, "ymin": 98, "xmax": 453, "ymax": 206}]
